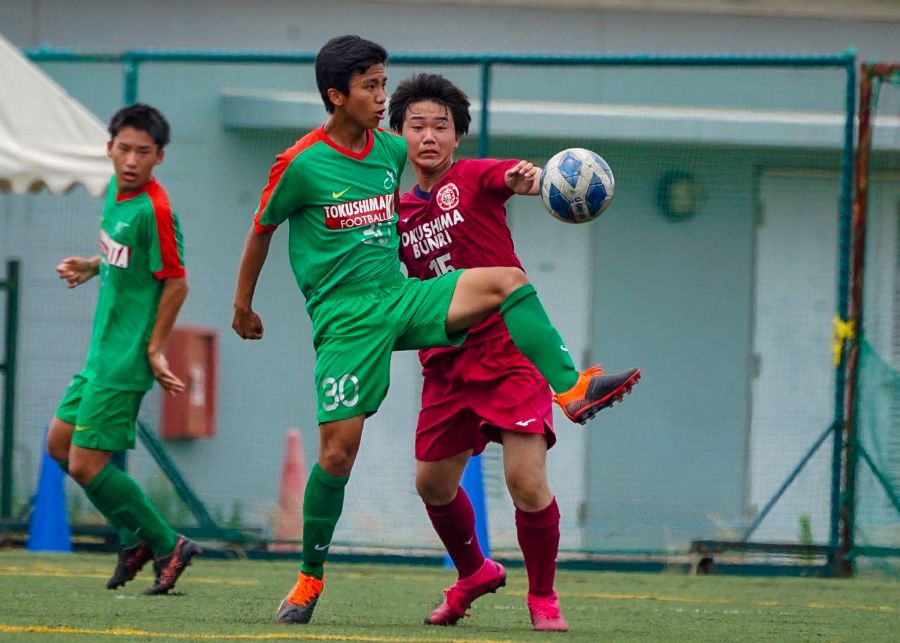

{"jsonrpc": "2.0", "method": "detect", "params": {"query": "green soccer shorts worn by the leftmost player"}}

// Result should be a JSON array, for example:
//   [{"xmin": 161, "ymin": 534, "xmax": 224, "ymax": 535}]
[{"xmin": 56, "ymin": 375, "xmax": 146, "ymax": 451}]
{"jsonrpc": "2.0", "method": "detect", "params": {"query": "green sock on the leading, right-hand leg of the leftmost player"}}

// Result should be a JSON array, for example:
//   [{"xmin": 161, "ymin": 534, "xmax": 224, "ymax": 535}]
[{"xmin": 84, "ymin": 464, "xmax": 178, "ymax": 556}]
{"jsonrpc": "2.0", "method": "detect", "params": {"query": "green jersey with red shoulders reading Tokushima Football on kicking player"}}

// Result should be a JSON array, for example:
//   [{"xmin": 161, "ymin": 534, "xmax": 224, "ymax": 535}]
[{"xmin": 254, "ymin": 127, "xmax": 406, "ymax": 310}]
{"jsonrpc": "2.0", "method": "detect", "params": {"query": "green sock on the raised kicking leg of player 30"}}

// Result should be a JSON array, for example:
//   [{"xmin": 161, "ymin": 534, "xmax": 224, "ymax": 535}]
[{"xmin": 500, "ymin": 284, "xmax": 578, "ymax": 393}]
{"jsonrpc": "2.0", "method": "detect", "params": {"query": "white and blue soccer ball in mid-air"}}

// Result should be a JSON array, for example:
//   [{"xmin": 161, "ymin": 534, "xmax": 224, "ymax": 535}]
[{"xmin": 541, "ymin": 147, "xmax": 616, "ymax": 223}]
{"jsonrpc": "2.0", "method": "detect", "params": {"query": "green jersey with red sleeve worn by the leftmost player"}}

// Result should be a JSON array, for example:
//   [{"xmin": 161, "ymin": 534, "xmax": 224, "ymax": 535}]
[{"xmin": 81, "ymin": 177, "xmax": 185, "ymax": 391}]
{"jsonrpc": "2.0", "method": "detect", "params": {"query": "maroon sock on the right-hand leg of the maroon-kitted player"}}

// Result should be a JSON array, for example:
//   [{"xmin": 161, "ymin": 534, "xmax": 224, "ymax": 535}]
[{"xmin": 516, "ymin": 498, "xmax": 559, "ymax": 596}]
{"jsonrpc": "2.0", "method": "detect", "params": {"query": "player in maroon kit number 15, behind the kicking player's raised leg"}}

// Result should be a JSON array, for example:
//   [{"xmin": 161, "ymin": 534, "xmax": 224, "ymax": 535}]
[{"xmin": 390, "ymin": 74, "xmax": 638, "ymax": 631}]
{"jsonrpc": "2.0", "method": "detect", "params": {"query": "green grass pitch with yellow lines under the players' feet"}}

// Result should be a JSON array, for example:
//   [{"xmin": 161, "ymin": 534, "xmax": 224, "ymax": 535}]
[{"xmin": 0, "ymin": 550, "xmax": 900, "ymax": 643}]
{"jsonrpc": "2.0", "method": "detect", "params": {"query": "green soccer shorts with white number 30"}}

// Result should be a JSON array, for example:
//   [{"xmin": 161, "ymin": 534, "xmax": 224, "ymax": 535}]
[{"xmin": 310, "ymin": 270, "xmax": 468, "ymax": 424}]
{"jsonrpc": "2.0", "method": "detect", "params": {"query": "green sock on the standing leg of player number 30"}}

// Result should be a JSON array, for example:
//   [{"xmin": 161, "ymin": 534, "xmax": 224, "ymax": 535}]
[{"xmin": 300, "ymin": 463, "xmax": 350, "ymax": 578}]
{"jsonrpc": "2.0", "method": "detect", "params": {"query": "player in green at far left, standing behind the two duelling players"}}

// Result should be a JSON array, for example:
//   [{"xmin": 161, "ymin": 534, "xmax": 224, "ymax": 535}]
[{"xmin": 47, "ymin": 104, "xmax": 200, "ymax": 594}]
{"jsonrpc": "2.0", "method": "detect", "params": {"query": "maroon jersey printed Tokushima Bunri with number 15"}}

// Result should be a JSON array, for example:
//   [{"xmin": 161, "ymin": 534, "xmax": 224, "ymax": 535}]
[{"xmin": 397, "ymin": 159, "xmax": 522, "ymax": 363}]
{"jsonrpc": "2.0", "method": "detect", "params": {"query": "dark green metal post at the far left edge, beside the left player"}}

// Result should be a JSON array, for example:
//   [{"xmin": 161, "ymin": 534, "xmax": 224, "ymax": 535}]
[{"xmin": 0, "ymin": 259, "xmax": 19, "ymax": 518}]
